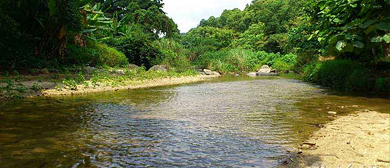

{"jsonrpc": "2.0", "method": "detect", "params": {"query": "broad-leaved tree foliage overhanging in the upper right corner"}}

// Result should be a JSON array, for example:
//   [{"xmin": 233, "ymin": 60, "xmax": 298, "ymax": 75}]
[{"xmin": 310, "ymin": 0, "xmax": 390, "ymax": 60}]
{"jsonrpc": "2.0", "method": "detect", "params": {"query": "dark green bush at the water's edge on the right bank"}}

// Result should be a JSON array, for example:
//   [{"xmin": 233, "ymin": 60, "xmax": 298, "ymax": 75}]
[{"xmin": 303, "ymin": 60, "xmax": 372, "ymax": 91}]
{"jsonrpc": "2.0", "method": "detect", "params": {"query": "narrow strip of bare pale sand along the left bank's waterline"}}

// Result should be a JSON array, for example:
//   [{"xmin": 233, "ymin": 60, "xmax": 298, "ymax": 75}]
[{"xmin": 1, "ymin": 75, "xmax": 219, "ymax": 97}]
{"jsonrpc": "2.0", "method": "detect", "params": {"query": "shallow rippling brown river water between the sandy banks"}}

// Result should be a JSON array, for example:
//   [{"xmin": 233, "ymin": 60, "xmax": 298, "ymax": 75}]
[{"xmin": 0, "ymin": 77, "xmax": 390, "ymax": 168}]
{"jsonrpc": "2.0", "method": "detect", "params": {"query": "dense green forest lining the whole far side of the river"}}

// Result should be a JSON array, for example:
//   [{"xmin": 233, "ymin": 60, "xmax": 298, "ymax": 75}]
[{"xmin": 0, "ymin": 0, "xmax": 390, "ymax": 91}]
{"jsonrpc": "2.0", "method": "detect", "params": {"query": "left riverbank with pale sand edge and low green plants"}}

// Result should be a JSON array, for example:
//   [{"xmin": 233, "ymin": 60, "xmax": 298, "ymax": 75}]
[{"xmin": 0, "ymin": 70, "xmax": 220, "ymax": 99}]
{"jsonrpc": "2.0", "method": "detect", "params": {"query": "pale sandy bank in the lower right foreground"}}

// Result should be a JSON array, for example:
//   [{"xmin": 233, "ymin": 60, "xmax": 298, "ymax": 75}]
[{"xmin": 280, "ymin": 110, "xmax": 390, "ymax": 168}]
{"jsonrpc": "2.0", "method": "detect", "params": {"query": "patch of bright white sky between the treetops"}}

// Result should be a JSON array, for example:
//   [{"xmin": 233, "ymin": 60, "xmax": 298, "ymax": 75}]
[{"xmin": 163, "ymin": 0, "xmax": 252, "ymax": 33}]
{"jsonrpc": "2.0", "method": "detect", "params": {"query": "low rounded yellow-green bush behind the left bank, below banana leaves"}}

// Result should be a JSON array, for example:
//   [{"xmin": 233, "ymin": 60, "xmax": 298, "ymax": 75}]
[{"xmin": 64, "ymin": 44, "xmax": 129, "ymax": 67}]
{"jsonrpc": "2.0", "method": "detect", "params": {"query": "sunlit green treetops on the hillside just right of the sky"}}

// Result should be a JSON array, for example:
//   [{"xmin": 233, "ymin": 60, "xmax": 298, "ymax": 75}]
[{"xmin": 198, "ymin": 0, "xmax": 306, "ymax": 54}]
